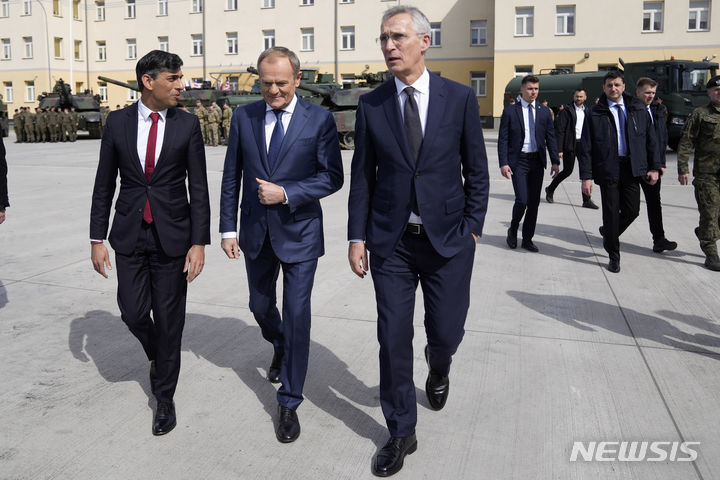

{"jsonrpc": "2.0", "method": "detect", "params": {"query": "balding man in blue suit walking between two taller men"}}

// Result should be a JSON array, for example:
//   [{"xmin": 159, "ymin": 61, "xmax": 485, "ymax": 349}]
[{"xmin": 220, "ymin": 47, "xmax": 343, "ymax": 443}]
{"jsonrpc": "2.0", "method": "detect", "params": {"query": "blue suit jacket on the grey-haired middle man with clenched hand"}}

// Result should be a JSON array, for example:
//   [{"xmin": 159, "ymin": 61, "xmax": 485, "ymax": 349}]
[{"xmin": 220, "ymin": 98, "xmax": 343, "ymax": 263}]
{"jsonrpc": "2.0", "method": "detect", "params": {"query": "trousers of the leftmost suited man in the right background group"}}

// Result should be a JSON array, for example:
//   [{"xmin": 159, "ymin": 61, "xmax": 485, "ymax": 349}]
[{"xmin": 510, "ymin": 157, "xmax": 545, "ymax": 241}]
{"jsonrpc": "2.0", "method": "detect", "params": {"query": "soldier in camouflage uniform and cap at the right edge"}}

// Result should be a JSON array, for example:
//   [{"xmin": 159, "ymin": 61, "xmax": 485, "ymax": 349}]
[{"xmin": 678, "ymin": 75, "xmax": 720, "ymax": 272}]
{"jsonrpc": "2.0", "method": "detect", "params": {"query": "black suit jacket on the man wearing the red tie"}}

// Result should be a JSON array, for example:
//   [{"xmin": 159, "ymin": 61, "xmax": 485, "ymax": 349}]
[{"xmin": 90, "ymin": 103, "xmax": 210, "ymax": 257}]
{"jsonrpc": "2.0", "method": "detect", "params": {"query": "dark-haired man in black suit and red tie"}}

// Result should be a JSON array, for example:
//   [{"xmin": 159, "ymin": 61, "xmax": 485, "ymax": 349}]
[{"xmin": 90, "ymin": 50, "xmax": 210, "ymax": 435}]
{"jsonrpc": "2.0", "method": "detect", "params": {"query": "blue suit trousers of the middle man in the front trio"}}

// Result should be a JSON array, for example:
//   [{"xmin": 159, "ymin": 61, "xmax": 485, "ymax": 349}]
[{"xmin": 245, "ymin": 235, "xmax": 317, "ymax": 410}]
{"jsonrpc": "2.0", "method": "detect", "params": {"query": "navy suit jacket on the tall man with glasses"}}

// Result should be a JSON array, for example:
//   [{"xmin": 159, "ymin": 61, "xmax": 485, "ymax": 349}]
[{"xmin": 348, "ymin": 74, "xmax": 489, "ymax": 258}]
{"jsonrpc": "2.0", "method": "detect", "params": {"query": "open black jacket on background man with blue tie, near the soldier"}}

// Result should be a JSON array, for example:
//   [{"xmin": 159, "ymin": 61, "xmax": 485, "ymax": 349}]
[{"xmin": 578, "ymin": 93, "xmax": 660, "ymax": 184}]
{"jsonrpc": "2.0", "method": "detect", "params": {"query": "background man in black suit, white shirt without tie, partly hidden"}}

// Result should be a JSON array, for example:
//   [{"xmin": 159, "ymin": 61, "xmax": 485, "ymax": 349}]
[{"xmin": 545, "ymin": 88, "xmax": 598, "ymax": 210}]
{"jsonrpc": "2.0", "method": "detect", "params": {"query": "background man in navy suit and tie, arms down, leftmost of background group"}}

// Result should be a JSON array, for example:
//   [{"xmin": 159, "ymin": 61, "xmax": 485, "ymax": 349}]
[{"xmin": 498, "ymin": 75, "xmax": 560, "ymax": 252}]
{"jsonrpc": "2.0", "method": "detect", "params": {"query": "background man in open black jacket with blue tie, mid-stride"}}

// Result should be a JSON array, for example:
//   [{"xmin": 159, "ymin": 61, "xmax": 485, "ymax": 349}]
[{"xmin": 578, "ymin": 70, "xmax": 660, "ymax": 273}]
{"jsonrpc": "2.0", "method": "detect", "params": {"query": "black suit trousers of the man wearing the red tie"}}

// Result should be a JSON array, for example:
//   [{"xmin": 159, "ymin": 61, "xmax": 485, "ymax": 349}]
[{"xmin": 115, "ymin": 222, "xmax": 187, "ymax": 401}]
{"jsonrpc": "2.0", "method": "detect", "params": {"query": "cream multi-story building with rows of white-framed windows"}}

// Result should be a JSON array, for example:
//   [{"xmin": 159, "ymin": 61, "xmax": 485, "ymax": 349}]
[{"xmin": 0, "ymin": 0, "xmax": 720, "ymax": 124}]
